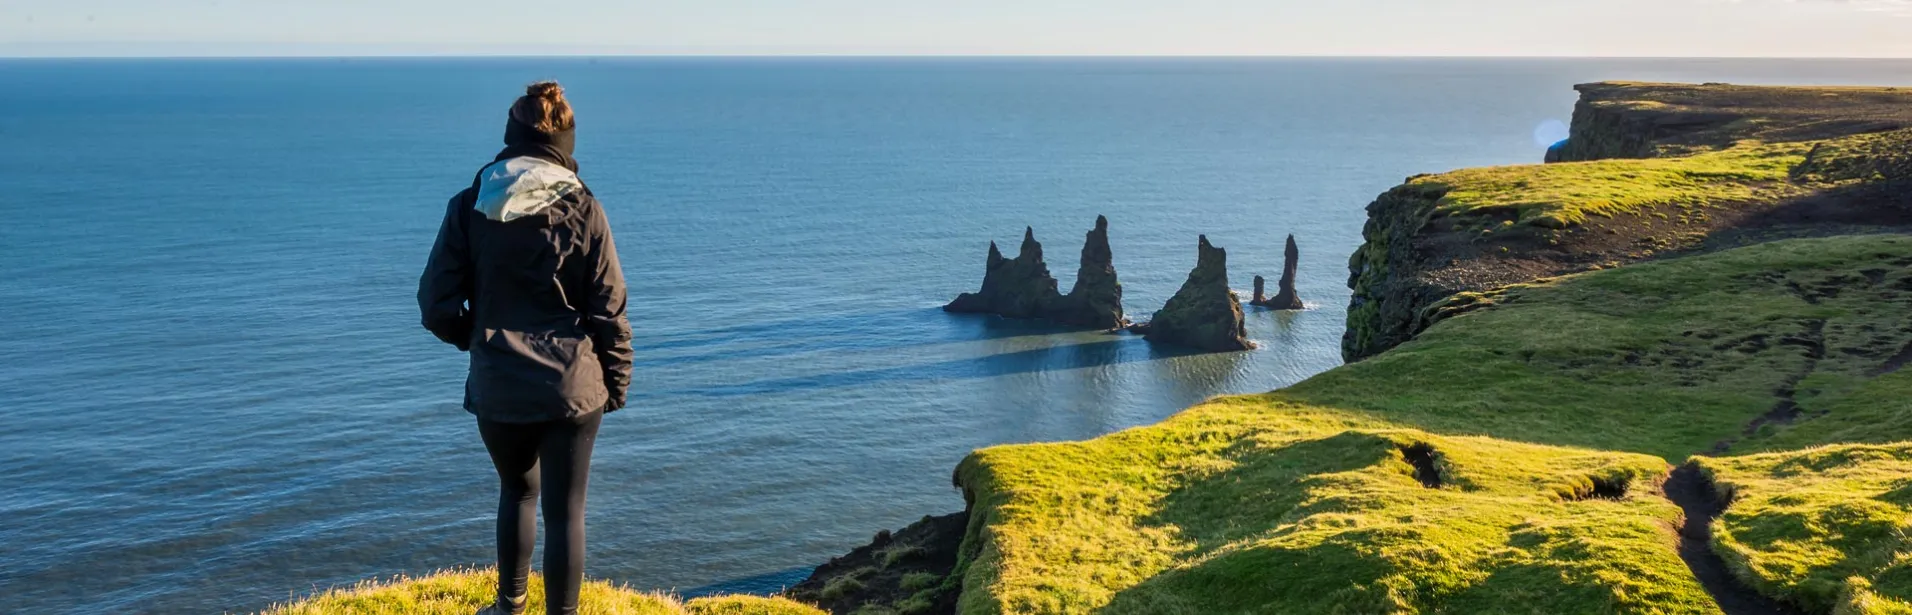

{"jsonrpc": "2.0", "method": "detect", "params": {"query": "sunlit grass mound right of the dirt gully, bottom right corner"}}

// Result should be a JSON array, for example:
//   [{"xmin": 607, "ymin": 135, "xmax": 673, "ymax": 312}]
[{"xmin": 1698, "ymin": 443, "xmax": 1912, "ymax": 613}]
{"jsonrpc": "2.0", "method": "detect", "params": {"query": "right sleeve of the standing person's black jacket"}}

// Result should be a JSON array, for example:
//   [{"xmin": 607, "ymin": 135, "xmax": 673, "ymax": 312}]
[{"xmin": 581, "ymin": 206, "xmax": 633, "ymax": 411}]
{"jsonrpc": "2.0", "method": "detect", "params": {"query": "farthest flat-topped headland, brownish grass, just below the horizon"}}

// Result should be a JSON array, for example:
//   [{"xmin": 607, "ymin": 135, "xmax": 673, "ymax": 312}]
[{"xmin": 1575, "ymin": 82, "xmax": 1912, "ymax": 153}]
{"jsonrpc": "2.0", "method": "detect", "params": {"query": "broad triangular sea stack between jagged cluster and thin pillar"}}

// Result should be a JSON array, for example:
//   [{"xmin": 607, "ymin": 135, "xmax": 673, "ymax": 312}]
[{"xmin": 1143, "ymin": 235, "xmax": 1254, "ymax": 351}]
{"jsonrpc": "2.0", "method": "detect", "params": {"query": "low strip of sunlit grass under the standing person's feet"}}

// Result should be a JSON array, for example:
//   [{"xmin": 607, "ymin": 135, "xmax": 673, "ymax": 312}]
[{"xmin": 262, "ymin": 571, "xmax": 824, "ymax": 615}]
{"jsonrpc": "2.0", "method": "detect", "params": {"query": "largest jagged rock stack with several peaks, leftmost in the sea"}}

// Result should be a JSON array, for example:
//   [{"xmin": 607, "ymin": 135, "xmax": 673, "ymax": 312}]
[{"xmin": 943, "ymin": 216, "xmax": 1128, "ymax": 329}]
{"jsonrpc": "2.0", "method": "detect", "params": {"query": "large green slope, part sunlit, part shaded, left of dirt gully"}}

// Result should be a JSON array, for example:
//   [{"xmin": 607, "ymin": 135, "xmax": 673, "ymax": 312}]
[{"xmin": 958, "ymin": 235, "xmax": 1912, "ymax": 613}]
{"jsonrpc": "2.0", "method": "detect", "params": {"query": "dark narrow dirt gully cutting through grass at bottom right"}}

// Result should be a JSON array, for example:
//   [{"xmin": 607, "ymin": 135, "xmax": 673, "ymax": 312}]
[{"xmin": 1665, "ymin": 464, "xmax": 1805, "ymax": 615}]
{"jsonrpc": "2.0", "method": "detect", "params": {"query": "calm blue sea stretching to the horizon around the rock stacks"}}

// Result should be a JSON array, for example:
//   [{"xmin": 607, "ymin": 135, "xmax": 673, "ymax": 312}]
[{"xmin": 0, "ymin": 59, "xmax": 1912, "ymax": 613}]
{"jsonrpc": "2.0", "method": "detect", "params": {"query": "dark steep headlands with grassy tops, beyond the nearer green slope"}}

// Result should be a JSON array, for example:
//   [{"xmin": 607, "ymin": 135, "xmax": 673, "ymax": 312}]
[{"xmin": 1342, "ymin": 82, "xmax": 1912, "ymax": 361}]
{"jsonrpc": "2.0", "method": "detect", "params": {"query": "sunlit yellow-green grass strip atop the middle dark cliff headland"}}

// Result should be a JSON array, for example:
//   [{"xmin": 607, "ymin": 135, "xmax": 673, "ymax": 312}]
[{"xmin": 1409, "ymin": 143, "xmax": 1811, "ymax": 229}]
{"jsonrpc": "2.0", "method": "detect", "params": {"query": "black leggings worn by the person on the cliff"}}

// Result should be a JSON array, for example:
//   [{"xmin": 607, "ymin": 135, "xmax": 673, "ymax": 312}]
[{"xmin": 478, "ymin": 413, "xmax": 604, "ymax": 615}]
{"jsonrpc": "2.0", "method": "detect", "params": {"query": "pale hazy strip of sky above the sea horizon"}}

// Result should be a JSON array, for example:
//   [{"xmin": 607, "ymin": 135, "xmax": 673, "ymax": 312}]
[{"xmin": 0, "ymin": 0, "xmax": 1912, "ymax": 57}]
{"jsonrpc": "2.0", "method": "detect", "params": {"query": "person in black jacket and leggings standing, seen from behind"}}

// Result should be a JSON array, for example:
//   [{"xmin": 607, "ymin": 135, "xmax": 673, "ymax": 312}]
[{"xmin": 419, "ymin": 82, "xmax": 633, "ymax": 615}]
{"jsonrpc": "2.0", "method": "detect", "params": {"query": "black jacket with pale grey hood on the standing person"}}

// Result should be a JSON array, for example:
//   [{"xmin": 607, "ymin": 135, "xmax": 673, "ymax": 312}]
[{"xmin": 419, "ymin": 151, "xmax": 631, "ymax": 422}]
